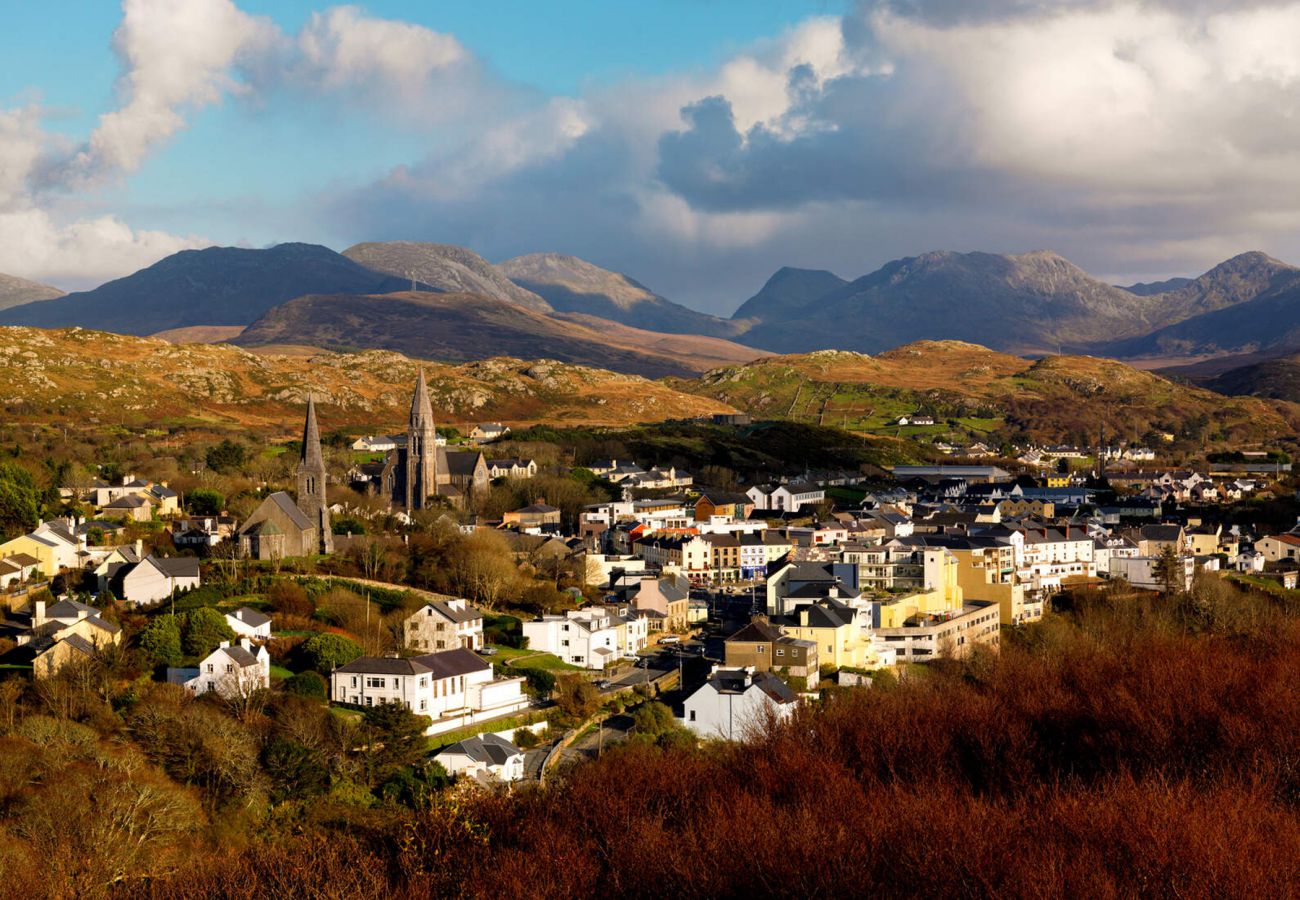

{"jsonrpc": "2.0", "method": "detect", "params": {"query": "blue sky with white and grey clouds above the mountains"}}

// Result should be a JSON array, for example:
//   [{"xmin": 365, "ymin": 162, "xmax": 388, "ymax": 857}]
[{"xmin": 0, "ymin": 0, "xmax": 1300, "ymax": 315}]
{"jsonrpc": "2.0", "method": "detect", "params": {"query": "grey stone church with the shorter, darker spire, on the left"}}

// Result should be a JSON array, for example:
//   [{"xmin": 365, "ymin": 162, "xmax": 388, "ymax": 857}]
[{"xmin": 238, "ymin": 397, "xmax": 334, "ymax": 559}]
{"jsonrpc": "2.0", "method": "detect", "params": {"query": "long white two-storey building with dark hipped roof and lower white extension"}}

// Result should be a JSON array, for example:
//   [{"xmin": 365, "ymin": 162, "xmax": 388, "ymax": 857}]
[{"xmin": 330, "ymin": 648, "xmax": 528, "ymax": 734}]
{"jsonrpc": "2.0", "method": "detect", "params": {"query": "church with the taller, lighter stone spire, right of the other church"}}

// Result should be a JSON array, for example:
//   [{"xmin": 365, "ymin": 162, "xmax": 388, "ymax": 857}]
[{"xmin": 378, "ymin": 369, "xmax": 491, "ymax": 512}]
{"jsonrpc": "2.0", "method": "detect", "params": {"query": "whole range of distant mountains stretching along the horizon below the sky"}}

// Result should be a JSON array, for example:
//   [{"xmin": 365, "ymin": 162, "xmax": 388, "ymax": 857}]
[{"xmin": 0, "ymin": 241, "xmax": 1300, "ymax": 366}]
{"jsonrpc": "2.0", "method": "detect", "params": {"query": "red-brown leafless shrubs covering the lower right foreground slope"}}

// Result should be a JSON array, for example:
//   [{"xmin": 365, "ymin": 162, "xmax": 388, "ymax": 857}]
[{"xmin": 119, "ymin": 590, "xmax": 1300, "ymax": 897}]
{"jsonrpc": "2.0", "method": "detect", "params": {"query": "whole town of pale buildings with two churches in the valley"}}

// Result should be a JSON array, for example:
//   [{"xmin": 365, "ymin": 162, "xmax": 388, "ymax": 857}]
[{"xmin": 0, "ymin": 373, "xmax": 1300, "ymax": 811}]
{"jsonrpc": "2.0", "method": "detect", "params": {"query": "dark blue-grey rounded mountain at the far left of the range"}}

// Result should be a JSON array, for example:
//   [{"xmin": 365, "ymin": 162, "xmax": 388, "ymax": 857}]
[{"xmin": 0, "ymin": 243, "xmax": 411, "ymax": 336}]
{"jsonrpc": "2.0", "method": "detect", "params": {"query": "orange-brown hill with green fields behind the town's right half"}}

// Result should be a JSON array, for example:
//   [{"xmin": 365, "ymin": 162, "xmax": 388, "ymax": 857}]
[{"xmin": 671, "ymin": 341, "xmax": 1300, "ymax": 441}]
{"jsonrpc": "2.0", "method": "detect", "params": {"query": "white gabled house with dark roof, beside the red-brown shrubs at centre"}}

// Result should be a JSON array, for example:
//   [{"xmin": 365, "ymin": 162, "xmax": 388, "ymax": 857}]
[{"xmin": 681, "ymin": 668, "xmax": 798, "ymax": 740}]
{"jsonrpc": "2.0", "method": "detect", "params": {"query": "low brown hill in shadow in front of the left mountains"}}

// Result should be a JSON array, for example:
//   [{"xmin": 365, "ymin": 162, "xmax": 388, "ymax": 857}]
[{"xmin": 234, "ymin": 291, "xmax": 753, "ymax": 377}]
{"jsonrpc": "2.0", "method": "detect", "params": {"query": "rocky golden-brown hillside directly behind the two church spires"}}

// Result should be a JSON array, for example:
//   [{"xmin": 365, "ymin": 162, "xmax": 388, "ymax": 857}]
[{"xmin": 0, "ymin": 328, "xmax": 728, "ymax": 429}]
